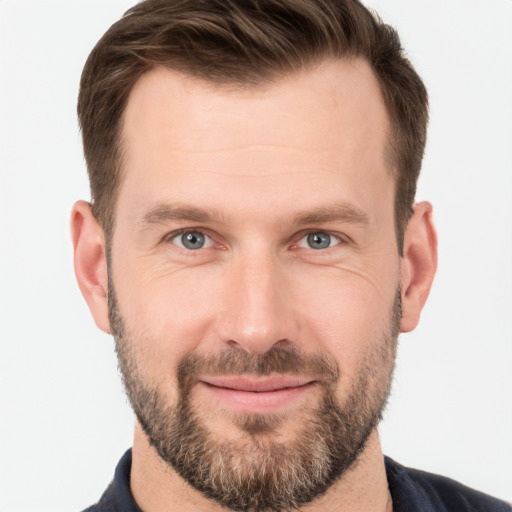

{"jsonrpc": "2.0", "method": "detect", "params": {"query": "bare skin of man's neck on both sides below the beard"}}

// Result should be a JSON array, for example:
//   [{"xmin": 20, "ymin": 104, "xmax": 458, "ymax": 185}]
[{"xmin": 130, "ymin": 424, "xmax": 392, "ymax": 512}]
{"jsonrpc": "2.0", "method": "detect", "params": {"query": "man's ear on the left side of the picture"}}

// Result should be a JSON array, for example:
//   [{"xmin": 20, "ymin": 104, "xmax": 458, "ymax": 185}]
[{"xmin": 71, "ymin": 201, "xmax": 110, "ymax": 333}]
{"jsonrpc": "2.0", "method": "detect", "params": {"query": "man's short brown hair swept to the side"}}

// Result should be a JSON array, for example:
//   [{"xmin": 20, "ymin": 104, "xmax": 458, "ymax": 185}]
[{"xmin": 78, "ymin": 0, "xmax": 428, "ymax": 250}]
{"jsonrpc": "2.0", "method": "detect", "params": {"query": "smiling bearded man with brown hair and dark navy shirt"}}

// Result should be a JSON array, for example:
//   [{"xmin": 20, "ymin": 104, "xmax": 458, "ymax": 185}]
[{"xmin": 72, "ymin": 0, "xmax": 511, "ymax": 512}]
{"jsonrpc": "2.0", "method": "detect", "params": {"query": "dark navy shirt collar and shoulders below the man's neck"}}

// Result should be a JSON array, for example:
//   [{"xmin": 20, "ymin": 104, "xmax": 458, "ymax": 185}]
[{"xmin": 84, "ymin": 450, "xmax": 512, "ymax": 512}]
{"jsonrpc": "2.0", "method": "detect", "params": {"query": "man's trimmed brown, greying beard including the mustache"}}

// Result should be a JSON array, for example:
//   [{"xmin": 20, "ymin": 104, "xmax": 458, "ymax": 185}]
[{"xmin": 108, "ymin": 284, "xmax": 401, "ymax": 512}]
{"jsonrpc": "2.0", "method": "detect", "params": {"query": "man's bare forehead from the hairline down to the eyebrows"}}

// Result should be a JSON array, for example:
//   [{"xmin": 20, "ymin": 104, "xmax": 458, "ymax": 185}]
[{"xmin": 120, "ymin": 59, "xmax": 391, "ymax": 222}]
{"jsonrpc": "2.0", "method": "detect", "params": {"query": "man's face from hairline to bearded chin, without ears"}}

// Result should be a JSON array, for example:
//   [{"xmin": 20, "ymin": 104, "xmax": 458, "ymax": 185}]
[{"xmin": 109, "ymin": 60, "xmax": 400, "ymax": 510}]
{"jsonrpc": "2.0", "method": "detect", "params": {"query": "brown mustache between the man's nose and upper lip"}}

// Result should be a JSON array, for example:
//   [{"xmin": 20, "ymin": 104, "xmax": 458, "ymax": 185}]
[{"xmin": 176, "ymin": 345, "xmax": 340, "ymax": 390}]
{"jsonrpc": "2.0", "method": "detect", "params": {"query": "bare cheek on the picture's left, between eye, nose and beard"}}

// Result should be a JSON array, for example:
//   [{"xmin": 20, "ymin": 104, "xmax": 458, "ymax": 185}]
[{"xmin": 114, "ymin": 260, "xmax": 222, "ymax": 358}]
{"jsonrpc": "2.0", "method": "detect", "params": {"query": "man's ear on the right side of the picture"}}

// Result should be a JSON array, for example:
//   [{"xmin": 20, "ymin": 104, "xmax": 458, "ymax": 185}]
[{"xmin": 400, "ymin": 202, "xmax": 437, "ymax": 332}]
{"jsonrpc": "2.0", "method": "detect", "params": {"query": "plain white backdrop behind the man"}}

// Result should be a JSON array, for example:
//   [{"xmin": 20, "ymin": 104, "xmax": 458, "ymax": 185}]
[{"xmin": 0, "ymin": 0, "xmax": 512, "ymax": 512}]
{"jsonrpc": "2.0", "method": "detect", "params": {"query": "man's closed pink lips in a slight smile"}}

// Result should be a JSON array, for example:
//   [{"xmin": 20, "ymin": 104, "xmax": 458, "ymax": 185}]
[{"xmin": 200, "ymin": 376, "xmax": 318, "ymax": 414}]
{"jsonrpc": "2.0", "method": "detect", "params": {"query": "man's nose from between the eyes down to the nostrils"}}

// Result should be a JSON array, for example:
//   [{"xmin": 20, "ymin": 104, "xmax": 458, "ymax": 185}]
[{"xmin": 218, "ymin": 250, "xmax": 298, "ymax": 354}]
